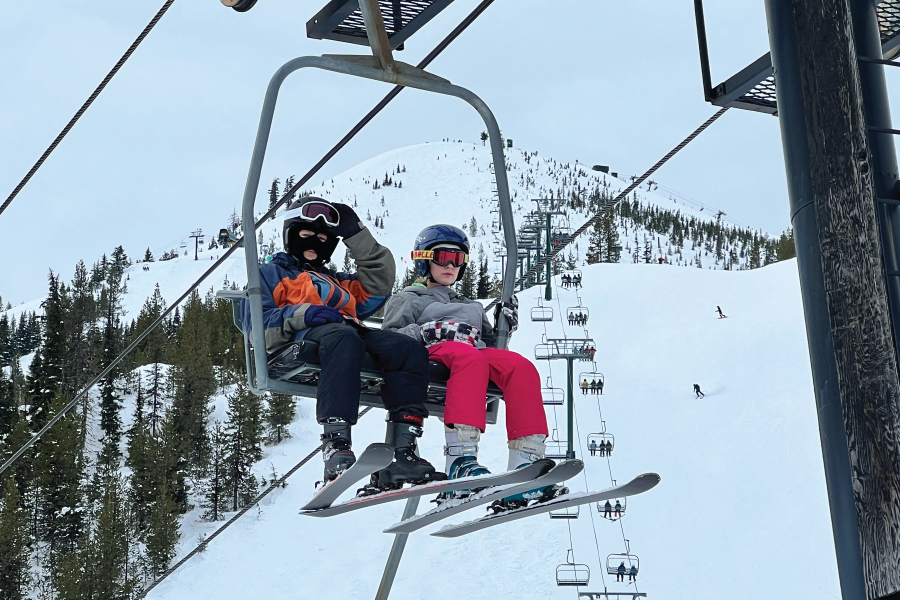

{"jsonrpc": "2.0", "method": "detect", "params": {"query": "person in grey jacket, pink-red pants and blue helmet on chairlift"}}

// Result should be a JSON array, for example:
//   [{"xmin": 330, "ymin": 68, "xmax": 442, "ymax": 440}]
[{"xmin": 383, "ymin": 225, "xmax": 553, "ymax": 506}]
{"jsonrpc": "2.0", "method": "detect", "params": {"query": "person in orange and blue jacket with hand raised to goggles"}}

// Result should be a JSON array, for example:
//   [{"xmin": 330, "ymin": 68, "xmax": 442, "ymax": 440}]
[{"xmin": 242, "ymin": 196, "xmax": 446, "ymax": 488}]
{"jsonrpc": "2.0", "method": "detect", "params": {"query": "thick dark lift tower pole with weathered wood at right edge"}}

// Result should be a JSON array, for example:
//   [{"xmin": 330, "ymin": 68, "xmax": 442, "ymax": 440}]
[{"xmin": 765, "ymin": 0, "xmax": 900, "ymax": 600}]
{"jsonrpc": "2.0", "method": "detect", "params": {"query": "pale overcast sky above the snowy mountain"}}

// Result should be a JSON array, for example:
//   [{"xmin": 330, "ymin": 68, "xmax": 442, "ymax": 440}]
[{"xmin": 0, "ymin": 0, "xmax": 900, "ymax": 304}]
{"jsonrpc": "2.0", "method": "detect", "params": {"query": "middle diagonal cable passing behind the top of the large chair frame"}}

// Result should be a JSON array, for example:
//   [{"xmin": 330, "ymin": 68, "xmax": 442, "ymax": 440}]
[{"xmin": 0, "ymin": 0, "xmax": 494, "ymax": 474}]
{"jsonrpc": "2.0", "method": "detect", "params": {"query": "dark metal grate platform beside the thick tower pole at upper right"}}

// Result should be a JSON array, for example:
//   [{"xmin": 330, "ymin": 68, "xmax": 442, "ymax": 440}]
[{"xmin": 711, "ymin": 0, "xmax": 900, "ymax": 115}]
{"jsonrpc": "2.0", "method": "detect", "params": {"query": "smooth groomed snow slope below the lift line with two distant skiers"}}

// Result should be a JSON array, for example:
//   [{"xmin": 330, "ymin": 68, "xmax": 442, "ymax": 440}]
[{"xmin": 141, "ymin": 261, "xmax": 839, "ymax": 600}]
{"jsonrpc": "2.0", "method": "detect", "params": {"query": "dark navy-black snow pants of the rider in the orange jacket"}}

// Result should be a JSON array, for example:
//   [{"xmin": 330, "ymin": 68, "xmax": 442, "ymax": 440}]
[{"xmin": 303, "ymin": 323, "xmax": 429, "ymax": 424}]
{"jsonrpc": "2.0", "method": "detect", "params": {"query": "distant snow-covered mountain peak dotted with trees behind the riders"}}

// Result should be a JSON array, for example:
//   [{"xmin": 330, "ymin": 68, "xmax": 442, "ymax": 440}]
[{"xmin": 0, "ymin": 142, "xmax": 740, "ymax": 319}]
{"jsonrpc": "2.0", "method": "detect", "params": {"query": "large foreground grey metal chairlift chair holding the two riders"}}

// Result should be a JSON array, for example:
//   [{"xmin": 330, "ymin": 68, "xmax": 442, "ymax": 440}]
[{"xmin": 214, "ymin": 0, "xmax": 517, "ymax": 423}]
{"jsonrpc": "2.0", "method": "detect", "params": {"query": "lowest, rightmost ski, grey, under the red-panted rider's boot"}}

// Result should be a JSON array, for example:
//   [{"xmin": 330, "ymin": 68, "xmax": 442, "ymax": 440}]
[{"xmin": 431, "ymin": 473, "xmax": 659, "ymax": 538}]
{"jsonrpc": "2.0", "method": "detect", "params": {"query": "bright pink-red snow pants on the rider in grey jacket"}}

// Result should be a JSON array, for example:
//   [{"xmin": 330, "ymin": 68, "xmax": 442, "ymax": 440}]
[{"xmin": 428, "ymin": 342, "xmax": 547, "ymax": 440}]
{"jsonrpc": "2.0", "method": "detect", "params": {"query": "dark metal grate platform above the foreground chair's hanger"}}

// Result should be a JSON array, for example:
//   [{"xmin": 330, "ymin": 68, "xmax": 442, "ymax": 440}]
[{"xmin": 306, "ymin": 0, "xmax": 453, "ymax": 50}]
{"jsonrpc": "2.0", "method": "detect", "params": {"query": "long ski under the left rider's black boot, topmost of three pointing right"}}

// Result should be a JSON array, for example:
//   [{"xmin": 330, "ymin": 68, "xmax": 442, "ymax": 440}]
[{"xmin": 300, "ymin": 458, "xmax": 556, "ymax": 517}]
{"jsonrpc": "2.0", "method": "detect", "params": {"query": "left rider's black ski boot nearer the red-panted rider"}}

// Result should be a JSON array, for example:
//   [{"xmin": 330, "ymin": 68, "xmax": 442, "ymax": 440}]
[{"xmin": 371, "ymin": 418, "xmax": 447, "ymax": 491}]
